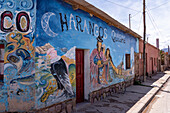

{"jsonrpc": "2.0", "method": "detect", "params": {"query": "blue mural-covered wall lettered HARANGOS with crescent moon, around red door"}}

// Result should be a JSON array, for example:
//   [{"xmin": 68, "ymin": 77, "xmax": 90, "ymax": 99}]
[{"xmin": 35, "ymin": 0, "xmax": 138, "ymax": 108}]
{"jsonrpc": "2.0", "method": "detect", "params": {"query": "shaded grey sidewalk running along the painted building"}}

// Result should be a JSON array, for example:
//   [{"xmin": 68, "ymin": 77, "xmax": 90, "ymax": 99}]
[{"xmin": 75, "ymin": 71, "xmax": 170, "ymax": 113}]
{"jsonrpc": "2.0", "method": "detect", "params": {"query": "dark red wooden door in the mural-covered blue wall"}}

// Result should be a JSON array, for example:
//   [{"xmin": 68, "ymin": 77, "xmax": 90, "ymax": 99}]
[{"xmin": 76, "ymin": 49, "xmax": 84, "ymax": 103}]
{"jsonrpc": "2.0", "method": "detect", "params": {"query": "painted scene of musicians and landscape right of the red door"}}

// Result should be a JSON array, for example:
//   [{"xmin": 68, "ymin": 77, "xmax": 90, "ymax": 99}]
[{"xmin": 90, "ymin": 37, "xmax": 134, "ymax": 90}]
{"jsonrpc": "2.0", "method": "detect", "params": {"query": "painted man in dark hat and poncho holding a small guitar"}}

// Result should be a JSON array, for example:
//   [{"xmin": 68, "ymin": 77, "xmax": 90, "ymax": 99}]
[{"xmin": 90, "ymin": 37, "xmax": 108, "ymax": 87}]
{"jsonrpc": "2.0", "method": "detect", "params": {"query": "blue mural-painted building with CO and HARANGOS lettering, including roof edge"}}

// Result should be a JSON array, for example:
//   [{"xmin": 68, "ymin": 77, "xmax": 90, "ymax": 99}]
[{"xmin": 0, "ymin": 0, "xmax": 141, "ymax": 112}]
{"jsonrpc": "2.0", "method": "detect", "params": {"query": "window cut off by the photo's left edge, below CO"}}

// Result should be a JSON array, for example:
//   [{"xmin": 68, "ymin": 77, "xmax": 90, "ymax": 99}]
[{"xmin": 0, "ymin": 44, "xmax": 5, "ymax": 82}]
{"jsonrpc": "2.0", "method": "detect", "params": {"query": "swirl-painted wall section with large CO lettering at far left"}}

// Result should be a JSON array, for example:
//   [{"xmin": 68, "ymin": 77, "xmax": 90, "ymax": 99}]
[{"xmin": 0, "ymin": 0, "xmax": 36, "ymax": 112}]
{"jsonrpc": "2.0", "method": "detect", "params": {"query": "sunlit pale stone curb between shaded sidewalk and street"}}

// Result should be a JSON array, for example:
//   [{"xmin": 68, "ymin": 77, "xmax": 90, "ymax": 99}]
[{"xmin": 127, "ymin": 73, "xmax": 170, "ymax": 113}]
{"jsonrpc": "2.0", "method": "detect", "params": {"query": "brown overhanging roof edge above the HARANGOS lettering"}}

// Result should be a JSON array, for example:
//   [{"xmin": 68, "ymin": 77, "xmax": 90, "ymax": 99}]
[{"xmin": 64, "ymin": 0, "xmax": 142, "ymax": 39}]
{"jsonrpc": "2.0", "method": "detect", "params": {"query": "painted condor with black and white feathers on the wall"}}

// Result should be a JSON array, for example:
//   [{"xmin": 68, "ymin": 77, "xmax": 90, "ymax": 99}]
[{"xmin": 47, "ymin": 48, "xmax": 74, "ymax": 97}]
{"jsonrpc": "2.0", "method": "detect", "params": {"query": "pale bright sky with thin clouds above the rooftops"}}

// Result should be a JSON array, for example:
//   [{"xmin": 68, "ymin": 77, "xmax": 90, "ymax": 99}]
[{"xmin": 86, "ymin": 0, "xmax": 170, "ymax": 49}]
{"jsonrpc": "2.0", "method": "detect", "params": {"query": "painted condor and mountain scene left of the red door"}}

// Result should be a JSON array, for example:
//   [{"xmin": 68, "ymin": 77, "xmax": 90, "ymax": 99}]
[{"xmin": 35, "ymin": 43, "xmax": 75, "ymax": 107}]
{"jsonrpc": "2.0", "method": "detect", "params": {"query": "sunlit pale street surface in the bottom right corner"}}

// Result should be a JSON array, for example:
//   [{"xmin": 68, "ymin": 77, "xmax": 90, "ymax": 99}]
[{"xmin": 143, "ymin": 73, "xmax": 170, "ymax": 113}]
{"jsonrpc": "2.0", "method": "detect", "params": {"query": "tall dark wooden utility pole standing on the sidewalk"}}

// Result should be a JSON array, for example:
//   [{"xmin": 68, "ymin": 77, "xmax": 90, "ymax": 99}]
[{"xmin": 143, "ymin": 0, "xmax": 146, "ymax": 82}]
